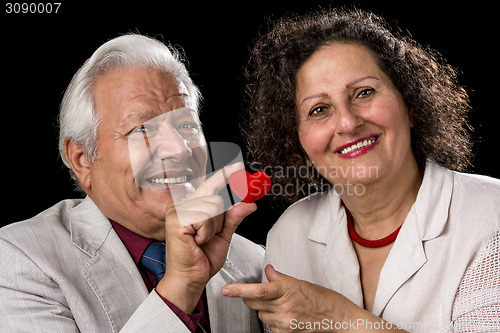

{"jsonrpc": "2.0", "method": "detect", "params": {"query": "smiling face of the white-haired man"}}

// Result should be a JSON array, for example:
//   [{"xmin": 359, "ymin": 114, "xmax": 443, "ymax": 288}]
[{"xmin": 84, "ymin": 69, "xmax": 207, "ymax": 239}]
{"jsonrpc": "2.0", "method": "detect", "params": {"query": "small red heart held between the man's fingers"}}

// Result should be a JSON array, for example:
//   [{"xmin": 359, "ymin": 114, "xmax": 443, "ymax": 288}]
[{"xmin": 229, "ymin": 170, "xmax": 271, "ymax": 203}]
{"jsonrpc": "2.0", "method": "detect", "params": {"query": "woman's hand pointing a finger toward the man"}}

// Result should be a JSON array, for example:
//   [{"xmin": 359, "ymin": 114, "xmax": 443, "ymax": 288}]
[{"xmin": 222, "ymin": 265, "xmax": 404, "ymax": 333}]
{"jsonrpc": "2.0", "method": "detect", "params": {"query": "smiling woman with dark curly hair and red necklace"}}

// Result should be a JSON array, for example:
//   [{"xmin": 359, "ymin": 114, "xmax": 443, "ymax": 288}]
[{"xmin": 223, "ymin": 7, "xmax": 500, "ymax": 332}]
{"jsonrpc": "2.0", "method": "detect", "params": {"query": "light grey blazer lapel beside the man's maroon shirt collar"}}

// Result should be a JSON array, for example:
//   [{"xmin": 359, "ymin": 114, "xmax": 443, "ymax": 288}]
[{"xmin": 71, "ymin": 197, "xmax": 148, "ymax": 331}]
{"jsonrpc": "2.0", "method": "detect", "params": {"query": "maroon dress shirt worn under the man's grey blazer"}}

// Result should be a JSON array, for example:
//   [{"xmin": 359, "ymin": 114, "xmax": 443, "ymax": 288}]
[{"xmin": 110, "ymin": 220, "xmax": 210, "ymax": 333}]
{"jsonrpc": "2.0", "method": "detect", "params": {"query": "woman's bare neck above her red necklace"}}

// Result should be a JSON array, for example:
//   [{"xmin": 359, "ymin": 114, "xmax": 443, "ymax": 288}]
[{"xmin": 341, "ymin": 161, "xmax": 422, "ymax": 240}]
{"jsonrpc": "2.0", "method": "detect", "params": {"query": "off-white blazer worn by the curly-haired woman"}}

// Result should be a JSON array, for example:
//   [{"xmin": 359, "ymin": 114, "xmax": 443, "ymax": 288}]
[{"xmin": 266, "ymin": 162, "xmax": 500, "ymax": 333}]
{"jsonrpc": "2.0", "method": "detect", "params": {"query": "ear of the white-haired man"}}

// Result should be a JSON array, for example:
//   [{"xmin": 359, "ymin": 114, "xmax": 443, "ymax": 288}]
[{"xmin": 64, "ymin": 139, "xmax": 91, "ymax": 193}]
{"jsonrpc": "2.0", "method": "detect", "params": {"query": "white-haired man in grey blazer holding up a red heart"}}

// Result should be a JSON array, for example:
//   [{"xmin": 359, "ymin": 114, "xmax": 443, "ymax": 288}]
[{"xmin": 0, "ymin": 35, "xmax": 264, "ymax": 333}]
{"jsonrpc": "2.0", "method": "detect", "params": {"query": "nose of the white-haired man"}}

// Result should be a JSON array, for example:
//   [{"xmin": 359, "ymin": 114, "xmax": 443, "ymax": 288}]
[{"xmin": 156, "ymin": 126, "xmax": 193, "ymax": 163}]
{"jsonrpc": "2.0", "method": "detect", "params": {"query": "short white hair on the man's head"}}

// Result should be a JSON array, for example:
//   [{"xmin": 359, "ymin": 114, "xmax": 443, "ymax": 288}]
[{"xmin": 59, "ymin": 34, "xmax": 201, "ymax": 181}]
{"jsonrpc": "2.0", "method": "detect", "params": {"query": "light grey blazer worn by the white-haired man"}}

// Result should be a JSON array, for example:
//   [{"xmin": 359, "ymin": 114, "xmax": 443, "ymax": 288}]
[{"xmin": 0, "ymin": 198, "xmax": 264, "ymax": 333}]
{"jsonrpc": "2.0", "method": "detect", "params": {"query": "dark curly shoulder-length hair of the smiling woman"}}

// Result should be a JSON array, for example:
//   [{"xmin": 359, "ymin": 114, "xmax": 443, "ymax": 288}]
[{"xmin": 243, "ymin": 9, "xmax": 472, "ymax": 201}]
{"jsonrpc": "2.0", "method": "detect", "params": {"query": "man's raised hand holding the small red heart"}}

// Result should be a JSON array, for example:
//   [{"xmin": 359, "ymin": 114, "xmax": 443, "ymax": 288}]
[{"xmin": 156, "ymin": 163, "xmax": 257, "ymax": 313}]
